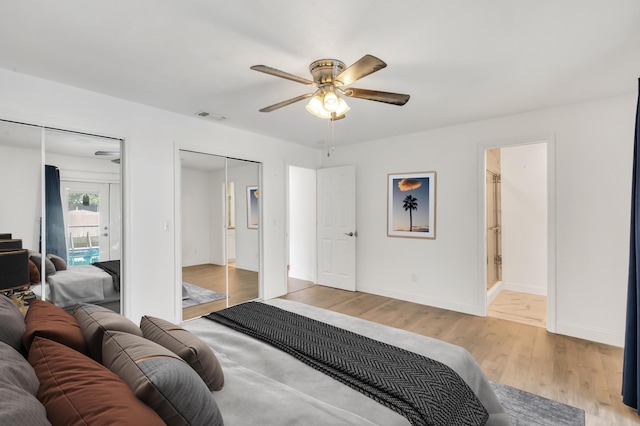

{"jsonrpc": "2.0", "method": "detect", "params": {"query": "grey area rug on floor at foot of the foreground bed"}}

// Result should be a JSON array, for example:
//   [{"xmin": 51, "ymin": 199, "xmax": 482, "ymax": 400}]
[{"xmin": 491, "ymin": 382, "xmax": 585, "ymax": 426}]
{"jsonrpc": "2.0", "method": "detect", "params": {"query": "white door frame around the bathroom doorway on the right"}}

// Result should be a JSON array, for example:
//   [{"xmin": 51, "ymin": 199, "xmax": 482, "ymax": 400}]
[{"xmin": 477, "ymin": 134, "xmax": 557, "ymax": 333}]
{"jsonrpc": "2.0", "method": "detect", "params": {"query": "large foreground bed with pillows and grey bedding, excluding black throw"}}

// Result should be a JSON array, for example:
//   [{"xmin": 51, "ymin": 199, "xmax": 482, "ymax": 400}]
[{"xmin": 0, "ymin": 296, "xmax": 510, "ymax": 426}]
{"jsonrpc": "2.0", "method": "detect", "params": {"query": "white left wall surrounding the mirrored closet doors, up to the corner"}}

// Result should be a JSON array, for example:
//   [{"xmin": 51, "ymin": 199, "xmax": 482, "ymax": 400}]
[{"xmin": 0, "ymin": 70, "xmax": 321, "ymax": 321}]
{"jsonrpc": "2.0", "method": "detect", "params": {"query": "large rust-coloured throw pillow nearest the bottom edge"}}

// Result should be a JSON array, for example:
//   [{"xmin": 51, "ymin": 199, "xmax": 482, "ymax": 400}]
[{"xmin": 29, "ymin": 337, "xmax": 164, "ymax": 426}]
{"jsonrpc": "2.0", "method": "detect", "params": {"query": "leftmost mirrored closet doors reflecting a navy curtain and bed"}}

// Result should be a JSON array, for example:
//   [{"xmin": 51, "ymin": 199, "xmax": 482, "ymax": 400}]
[{"xmin": 0, "ymin": 120, "xmax": 122, "ymax": 311}]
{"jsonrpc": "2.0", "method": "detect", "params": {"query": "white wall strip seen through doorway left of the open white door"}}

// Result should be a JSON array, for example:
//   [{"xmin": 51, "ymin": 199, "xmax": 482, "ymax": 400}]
[{"xmin": 289, "ymin": 166, "xmax": 316, "ymax": 282}]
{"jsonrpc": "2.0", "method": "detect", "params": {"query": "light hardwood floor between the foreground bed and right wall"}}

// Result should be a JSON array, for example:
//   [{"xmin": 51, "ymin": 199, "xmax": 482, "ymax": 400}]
[{"xmin": 282, "ymin": 286, "xmax": 640, "ymax": 426}]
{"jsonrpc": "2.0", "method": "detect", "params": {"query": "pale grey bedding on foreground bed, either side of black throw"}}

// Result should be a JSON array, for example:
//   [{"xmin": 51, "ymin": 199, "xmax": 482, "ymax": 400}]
[{"xmin": 181, "ymin": 299, "xmax": 511, "ymax": 426}]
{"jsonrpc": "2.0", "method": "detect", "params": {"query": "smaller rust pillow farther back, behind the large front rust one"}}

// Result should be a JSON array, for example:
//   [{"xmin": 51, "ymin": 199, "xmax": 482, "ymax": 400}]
[{"xmin": 22, "ymin": 299, "xmax": 88, "ymax": 354}]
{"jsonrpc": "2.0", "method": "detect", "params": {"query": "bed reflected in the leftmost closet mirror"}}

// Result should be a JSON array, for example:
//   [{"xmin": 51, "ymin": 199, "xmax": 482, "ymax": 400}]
[{"xmin": 31, "ymin": 260, "xmax": 120, "ymax": 308}]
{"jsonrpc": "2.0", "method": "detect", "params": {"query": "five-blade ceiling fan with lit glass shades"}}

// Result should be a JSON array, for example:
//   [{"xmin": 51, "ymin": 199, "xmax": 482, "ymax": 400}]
[{"xmin": 251, "ymin": 55, "xmax": 409, "ymax": 121}]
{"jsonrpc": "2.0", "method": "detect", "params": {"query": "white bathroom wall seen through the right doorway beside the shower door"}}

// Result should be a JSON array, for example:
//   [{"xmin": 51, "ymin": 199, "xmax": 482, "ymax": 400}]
[{"xmin": 500, "ymin": 143, "xmax": 547, "ymax": 295}]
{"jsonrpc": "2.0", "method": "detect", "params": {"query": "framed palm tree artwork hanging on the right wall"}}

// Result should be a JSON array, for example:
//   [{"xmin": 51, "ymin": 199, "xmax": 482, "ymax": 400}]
[{"xmin": 387, "ymin": 172, "xmax": 436, "ymax": 239}]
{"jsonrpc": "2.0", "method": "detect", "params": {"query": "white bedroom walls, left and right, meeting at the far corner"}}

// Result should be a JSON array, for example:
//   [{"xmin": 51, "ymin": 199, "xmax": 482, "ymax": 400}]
[{"xmin": 0, "ymin": 66, "xmax": 637, "ymax": 345}]
